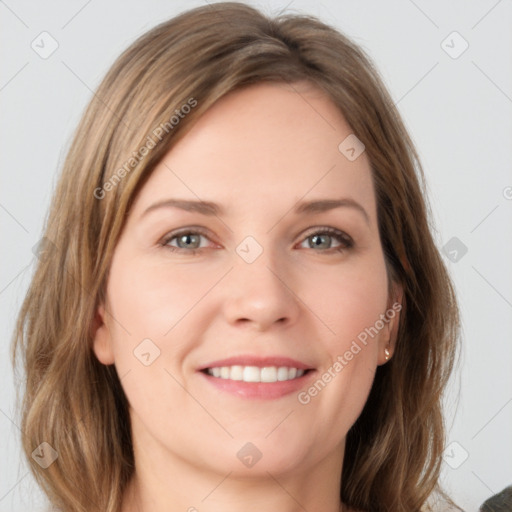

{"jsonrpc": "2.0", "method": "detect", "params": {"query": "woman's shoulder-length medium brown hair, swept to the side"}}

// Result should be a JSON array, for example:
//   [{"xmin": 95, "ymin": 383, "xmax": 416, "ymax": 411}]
[{"xmin": 13, "ymin": 3, "xmax": 459, "ymax": 512}]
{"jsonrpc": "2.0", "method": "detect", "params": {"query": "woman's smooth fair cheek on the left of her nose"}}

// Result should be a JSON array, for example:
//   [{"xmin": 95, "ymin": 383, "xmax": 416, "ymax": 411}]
[{"xmin": 103, "ymin": 251, "xmax": 218, "ymax": 420}]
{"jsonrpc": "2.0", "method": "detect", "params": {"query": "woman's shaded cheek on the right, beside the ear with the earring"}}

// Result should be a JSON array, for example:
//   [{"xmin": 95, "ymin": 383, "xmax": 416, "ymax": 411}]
[{"xmin": 299, "ymin": 254, "xmax": 388, "ymax": 426}]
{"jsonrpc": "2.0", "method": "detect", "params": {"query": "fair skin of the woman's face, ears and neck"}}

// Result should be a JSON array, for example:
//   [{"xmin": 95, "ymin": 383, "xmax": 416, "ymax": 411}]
[{"xmin": 93, "ymin": 82, "xmax": 401, "ymax": 512}]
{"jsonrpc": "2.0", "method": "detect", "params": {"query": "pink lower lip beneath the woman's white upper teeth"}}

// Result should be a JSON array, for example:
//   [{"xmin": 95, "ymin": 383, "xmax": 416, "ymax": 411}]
[{"xmin": 199, "ymin": 370, "xmax": 315, "ymax": 400}]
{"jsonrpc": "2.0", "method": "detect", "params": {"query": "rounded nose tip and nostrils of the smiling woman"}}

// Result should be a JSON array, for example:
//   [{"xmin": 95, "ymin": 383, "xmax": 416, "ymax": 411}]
[{"xmin": 223, "ymin": 252, "xmax": 300, "ymax": 331}]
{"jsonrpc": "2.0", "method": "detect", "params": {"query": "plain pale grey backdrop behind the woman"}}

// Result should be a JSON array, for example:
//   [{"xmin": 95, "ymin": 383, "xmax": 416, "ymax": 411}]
[{"xmin": 0, "ymin": 0, "xmax": 512, "ymax": 512}]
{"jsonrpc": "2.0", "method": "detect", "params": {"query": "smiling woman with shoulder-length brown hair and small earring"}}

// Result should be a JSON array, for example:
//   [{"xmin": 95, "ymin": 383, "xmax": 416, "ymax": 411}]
[{"xmin": 10, "ymin": 3, "xmax": 459, "ymax": 512}]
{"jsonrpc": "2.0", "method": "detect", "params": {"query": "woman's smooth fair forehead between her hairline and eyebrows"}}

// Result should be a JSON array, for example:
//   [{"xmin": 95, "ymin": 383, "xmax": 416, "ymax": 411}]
[{"xmin": 130, "ymin": 82, "xmax": 375, "ymax": 221}]
